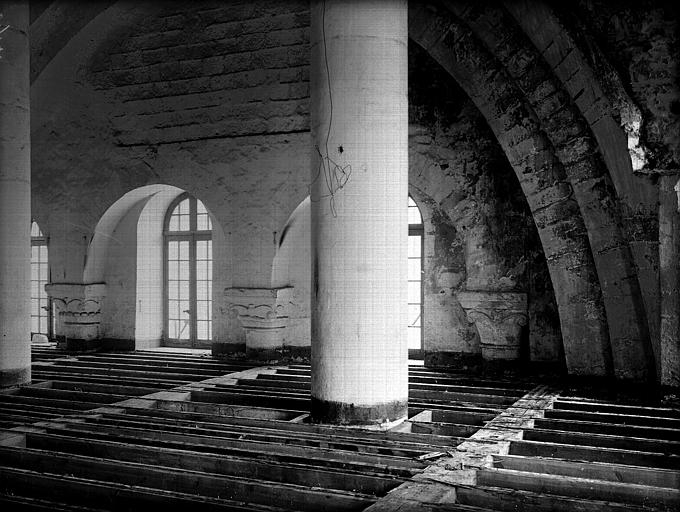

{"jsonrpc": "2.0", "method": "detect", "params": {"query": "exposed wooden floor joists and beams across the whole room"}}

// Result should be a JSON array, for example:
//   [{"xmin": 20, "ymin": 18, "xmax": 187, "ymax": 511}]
[{"xmin": 0, "ymin": 347, "xmax": 680, "ymax": 512}]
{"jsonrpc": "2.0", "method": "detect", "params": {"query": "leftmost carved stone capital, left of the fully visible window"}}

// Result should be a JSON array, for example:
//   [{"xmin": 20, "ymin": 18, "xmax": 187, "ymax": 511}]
[{"xmin": 45, "ymin": 283, "xmax": 106, "ymax": 341}]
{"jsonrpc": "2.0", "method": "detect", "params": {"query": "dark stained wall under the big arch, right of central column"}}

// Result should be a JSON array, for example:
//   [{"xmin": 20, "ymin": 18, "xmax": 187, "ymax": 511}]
[{"xmin": 409, "ymin": 45, "xmax": 561, "ymax": 361}]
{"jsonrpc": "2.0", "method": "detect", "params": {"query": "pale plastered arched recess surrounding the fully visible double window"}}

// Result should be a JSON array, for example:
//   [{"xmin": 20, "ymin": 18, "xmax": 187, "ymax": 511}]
[{"xmin": 83, "ymin": 184, "xmax": 228, "ymax": 349}]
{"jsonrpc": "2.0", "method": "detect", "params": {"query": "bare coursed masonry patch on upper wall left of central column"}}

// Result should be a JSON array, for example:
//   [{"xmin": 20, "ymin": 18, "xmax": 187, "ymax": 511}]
[{"xmin": 91, "ymin": 0, "xmax": 309, "ymax": 146}]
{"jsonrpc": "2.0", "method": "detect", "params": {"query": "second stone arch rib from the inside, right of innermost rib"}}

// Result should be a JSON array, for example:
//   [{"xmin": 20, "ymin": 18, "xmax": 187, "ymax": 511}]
[{"xmin": 450, "ymin": 2, "xmax": 655, "ymax": 379}]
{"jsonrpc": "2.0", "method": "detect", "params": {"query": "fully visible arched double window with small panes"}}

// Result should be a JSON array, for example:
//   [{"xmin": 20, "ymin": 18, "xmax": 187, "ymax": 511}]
[{"xmin": 163, "ymin": 193, "xmax": 212, "ymax": 347}]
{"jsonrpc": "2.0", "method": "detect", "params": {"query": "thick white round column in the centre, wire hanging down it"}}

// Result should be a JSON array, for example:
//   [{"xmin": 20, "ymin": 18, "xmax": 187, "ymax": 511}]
[{"xmin": 310, "ymin": 0, "xmax": 408, "ymax": 427}]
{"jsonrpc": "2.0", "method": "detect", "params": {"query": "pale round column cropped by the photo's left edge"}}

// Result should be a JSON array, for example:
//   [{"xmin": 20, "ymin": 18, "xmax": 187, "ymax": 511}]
[{"xmin": 0, "ymin": 1, "xmax": 31, "ymax": 387}]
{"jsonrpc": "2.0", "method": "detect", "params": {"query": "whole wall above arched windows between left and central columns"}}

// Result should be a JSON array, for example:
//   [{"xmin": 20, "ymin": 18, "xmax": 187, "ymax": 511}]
[{"xmin": 33, "ymin": 2, "xmax": 309, "ymax": 344}]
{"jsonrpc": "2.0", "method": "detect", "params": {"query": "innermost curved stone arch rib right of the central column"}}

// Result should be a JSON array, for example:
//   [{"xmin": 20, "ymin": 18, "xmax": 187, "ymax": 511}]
[{"xmin": 409, "ymin": 2, "xmax": 612, "ymax": 375}]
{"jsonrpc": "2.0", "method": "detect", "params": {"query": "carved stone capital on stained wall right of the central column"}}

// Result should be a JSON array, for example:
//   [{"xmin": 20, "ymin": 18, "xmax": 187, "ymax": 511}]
[{"xmin": 457, "ymin": 291, "xmax": 529, "ymax": 360}]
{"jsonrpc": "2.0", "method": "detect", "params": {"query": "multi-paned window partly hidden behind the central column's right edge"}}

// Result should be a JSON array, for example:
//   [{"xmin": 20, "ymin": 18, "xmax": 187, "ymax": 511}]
[{"xmin": 408, "ymin": 197, "xmax": 423, "ymax": 350}]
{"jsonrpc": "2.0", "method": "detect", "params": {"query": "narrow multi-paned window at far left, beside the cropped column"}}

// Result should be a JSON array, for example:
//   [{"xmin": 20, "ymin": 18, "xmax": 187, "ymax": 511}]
[{"xmin": 31, "ymin": 222, "xmax": 52, "ymax": 336}]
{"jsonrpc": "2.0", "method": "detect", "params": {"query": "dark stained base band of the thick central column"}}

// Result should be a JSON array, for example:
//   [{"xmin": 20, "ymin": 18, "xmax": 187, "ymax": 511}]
[{"xmin": 310, "ymin": 397, "xmax": 408, "ymax": 429}]
